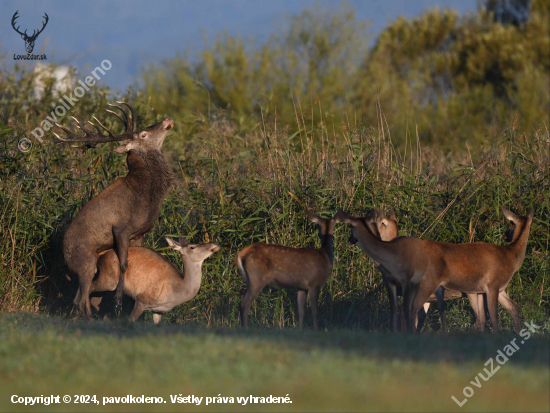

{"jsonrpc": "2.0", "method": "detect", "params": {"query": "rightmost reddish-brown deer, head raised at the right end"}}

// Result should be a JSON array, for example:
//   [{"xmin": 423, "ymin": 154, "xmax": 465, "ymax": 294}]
[{"xmin": 414, "ymin": 208, "xmax": 533, "ymax": 334}]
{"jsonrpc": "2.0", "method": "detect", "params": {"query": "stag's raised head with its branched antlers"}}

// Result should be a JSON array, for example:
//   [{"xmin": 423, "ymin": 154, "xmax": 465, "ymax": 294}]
[{"xmin": 55, "ymin": 102, "xmax": 174, "ymax": 154}]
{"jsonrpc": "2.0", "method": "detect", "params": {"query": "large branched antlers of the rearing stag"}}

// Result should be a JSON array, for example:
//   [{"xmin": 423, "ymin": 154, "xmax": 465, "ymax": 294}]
[{"xmin": 53, "ymin": 101, "xmax": 137, "ymax": 147}]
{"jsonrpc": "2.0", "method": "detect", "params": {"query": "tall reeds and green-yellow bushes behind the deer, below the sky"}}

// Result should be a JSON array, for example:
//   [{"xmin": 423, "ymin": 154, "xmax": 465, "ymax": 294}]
[{"xmin": 0, "ymin": 0, "xmax": 550, "ymax": 331}]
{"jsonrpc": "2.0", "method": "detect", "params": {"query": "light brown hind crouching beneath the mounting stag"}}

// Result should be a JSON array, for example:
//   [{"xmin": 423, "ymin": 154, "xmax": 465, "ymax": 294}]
[{"xmin": 79, "ymin": 238, "xmax": 220, "ymax": 324}]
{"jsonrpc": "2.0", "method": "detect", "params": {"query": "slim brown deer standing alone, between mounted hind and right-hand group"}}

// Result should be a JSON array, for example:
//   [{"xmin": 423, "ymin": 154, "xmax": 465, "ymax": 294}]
[{"xmin": 235, "ymin": 210, "xmax": 334, "ymax": 331}]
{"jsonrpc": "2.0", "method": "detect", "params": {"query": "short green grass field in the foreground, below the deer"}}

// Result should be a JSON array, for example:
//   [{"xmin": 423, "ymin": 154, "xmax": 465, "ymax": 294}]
[{"xmin": 0, "ymin": 314, "xmax": 550, "ymax": 412}]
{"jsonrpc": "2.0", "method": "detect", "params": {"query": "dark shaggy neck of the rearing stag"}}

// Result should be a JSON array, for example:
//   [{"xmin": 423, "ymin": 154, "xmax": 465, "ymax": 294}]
[{"xmin": 125, "ymin": 150, "xmax": 172, "ymax": 205}]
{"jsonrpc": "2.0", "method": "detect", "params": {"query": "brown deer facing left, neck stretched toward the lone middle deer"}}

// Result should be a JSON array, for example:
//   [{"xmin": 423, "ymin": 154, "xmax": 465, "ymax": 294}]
[{"xmin": 334, "ymin": 211, "xmax": 429, "ymax": 332}]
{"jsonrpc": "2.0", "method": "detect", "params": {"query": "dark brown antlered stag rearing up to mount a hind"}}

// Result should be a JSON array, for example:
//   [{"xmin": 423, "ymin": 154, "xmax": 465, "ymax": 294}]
[{"xmin": 56, "ymin": 102, "xmax": 174, "ymax": 318}]
